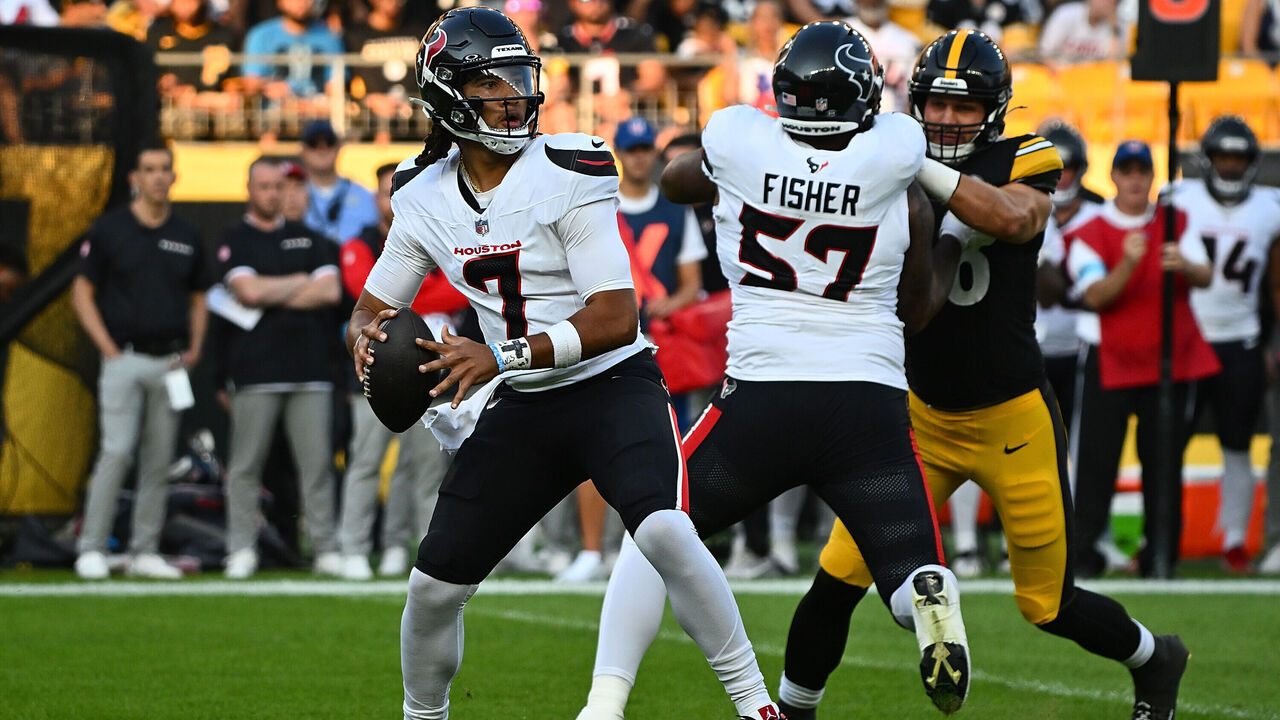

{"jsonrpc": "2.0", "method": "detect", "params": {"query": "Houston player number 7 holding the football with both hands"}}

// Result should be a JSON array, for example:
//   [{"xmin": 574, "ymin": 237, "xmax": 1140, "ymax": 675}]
[{"xmin": 348, "ymin": 8, "xmax": 778, "ymax": 720}]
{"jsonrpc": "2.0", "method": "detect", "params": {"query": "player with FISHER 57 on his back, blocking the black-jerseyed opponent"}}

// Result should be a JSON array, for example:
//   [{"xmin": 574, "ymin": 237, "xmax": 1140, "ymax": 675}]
[{"xmin": 579, "ymin": 22, "xmax": 969, "ymax": 720}]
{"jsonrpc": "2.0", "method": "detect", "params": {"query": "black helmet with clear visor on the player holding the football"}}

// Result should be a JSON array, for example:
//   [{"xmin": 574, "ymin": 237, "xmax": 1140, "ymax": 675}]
[{"xmin": 415, "ymin": 6, "xmax": 543, "ymax": 155}]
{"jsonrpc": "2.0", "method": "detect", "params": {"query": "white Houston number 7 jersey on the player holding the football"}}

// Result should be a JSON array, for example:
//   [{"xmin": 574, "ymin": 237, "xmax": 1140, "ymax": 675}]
[{"xmin": 365, "ymin": 133, "xmax": 648, "ymax": 391}]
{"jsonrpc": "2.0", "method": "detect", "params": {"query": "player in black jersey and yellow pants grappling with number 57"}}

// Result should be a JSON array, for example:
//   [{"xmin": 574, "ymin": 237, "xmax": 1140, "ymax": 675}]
[{"xmin": 780, "ymin": 29, "xmax": 1188, "ymax": 720}]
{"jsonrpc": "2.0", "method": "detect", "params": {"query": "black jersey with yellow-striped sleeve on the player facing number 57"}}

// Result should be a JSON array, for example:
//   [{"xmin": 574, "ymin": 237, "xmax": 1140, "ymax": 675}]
[{"xmin": 906, "ymin": 135, "xmax": 1062, "ymax": 410}]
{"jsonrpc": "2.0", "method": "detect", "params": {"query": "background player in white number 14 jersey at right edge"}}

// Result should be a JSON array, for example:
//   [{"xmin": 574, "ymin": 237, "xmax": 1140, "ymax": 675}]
[{"xmin": 1172, "ymin": 115, "xmax": 1280, "ymax": 573}]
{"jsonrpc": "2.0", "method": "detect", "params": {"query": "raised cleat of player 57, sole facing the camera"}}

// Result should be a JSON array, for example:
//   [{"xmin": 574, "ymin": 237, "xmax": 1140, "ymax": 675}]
[{"xmin": 911, "ymin": 570, "xmax": 969, "ymax": 715}]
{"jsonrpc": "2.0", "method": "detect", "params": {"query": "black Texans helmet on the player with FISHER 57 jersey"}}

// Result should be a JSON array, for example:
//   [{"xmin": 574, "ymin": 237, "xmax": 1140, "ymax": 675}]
[{"xmin": 773, "ymin": 20, "xmax": 884, "ymax": 136}]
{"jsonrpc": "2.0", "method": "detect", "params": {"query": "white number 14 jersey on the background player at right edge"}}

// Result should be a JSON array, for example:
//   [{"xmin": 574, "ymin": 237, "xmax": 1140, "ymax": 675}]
[{"xmin": 1174, "ymin": 179, "xmax": 1280, "ymax": 342}]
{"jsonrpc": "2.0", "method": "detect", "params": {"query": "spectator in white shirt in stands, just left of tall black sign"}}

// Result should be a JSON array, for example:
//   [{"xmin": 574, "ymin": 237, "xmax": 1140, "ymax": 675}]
[{"xmin": 1039, "ymin": 0, "xmax": 1129, "ymax": 64}]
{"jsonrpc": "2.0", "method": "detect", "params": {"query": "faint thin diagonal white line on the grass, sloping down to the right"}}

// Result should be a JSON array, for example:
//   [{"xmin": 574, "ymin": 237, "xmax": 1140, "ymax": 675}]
[{"xmin": 467, "ymin": 607, "xmax": 1280, "ymax": 720}]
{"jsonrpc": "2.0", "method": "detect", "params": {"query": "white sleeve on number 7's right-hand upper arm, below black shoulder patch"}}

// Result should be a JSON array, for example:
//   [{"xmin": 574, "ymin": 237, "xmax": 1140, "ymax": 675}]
[{"xmin": 556, "ymin": 197, "xmax": 635, "ymax": 300}]
